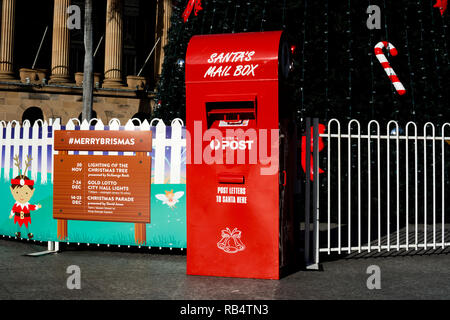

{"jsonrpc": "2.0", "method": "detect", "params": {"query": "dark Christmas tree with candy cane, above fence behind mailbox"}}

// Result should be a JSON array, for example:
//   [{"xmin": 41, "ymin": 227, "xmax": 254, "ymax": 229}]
[{"xmin": 155, "ymin": 0, "xmax": 450, "ymax": 123}]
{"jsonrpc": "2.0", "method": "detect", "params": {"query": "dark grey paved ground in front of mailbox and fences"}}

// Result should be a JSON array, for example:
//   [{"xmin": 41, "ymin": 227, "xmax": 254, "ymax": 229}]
[{"xmin": 0, "ymin": 240, "xmax": 450, "ymax": 300}]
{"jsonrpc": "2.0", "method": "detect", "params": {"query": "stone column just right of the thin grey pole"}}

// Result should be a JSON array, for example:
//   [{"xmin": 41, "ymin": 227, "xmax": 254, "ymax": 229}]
[{"xmin": 103, "ymin": 0, "xmax": 124, "ymax": 88}]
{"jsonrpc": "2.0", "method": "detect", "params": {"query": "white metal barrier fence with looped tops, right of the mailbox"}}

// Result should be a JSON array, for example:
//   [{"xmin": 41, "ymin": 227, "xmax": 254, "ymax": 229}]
[{"xmin": 305, "ymin": 119, "xmax": 450, "ymax": 268}]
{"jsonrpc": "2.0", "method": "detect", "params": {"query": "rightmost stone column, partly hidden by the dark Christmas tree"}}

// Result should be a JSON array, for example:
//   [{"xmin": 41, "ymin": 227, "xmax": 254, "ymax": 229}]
[{"xmin": 155, "ymin": 0, "xmax": 172, "ymax": 77}]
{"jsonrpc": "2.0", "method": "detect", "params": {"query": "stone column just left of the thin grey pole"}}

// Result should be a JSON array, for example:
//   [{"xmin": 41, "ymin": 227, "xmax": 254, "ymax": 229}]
[{"xmin": 49, "ymin": 0, "xmax": 71, "ymax": 83}]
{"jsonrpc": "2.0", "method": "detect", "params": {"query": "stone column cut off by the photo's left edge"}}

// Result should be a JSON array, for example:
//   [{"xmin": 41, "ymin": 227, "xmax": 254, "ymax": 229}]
[{"xmin": 0, "ymin": 0, "xmax": 16, "ymax": 81}]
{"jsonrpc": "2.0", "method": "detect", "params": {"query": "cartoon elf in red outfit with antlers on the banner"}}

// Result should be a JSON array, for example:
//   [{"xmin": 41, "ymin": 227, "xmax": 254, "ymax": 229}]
[{"xmin": 9, "ymin": 155, "xmax": 41, "ymax": 239}]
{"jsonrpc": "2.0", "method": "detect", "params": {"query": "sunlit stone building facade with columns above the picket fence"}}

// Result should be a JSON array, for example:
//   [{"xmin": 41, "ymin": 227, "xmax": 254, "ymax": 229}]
[{"xmin": 0, "ymin": 0, "xmax": 171, "ymax": 123}]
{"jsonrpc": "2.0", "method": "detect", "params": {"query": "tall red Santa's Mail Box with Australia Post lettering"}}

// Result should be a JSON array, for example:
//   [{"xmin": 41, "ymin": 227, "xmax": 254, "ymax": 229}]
[{"xmin": 186, "ymin": 31, "xmax": 299, "ymax": 279}]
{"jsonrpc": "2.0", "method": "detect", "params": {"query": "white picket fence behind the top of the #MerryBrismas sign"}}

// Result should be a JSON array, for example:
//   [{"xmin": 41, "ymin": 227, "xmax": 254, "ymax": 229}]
[{"xmin": 0, "ymin": 119, "xmax": 186, "ymax": 184}]
